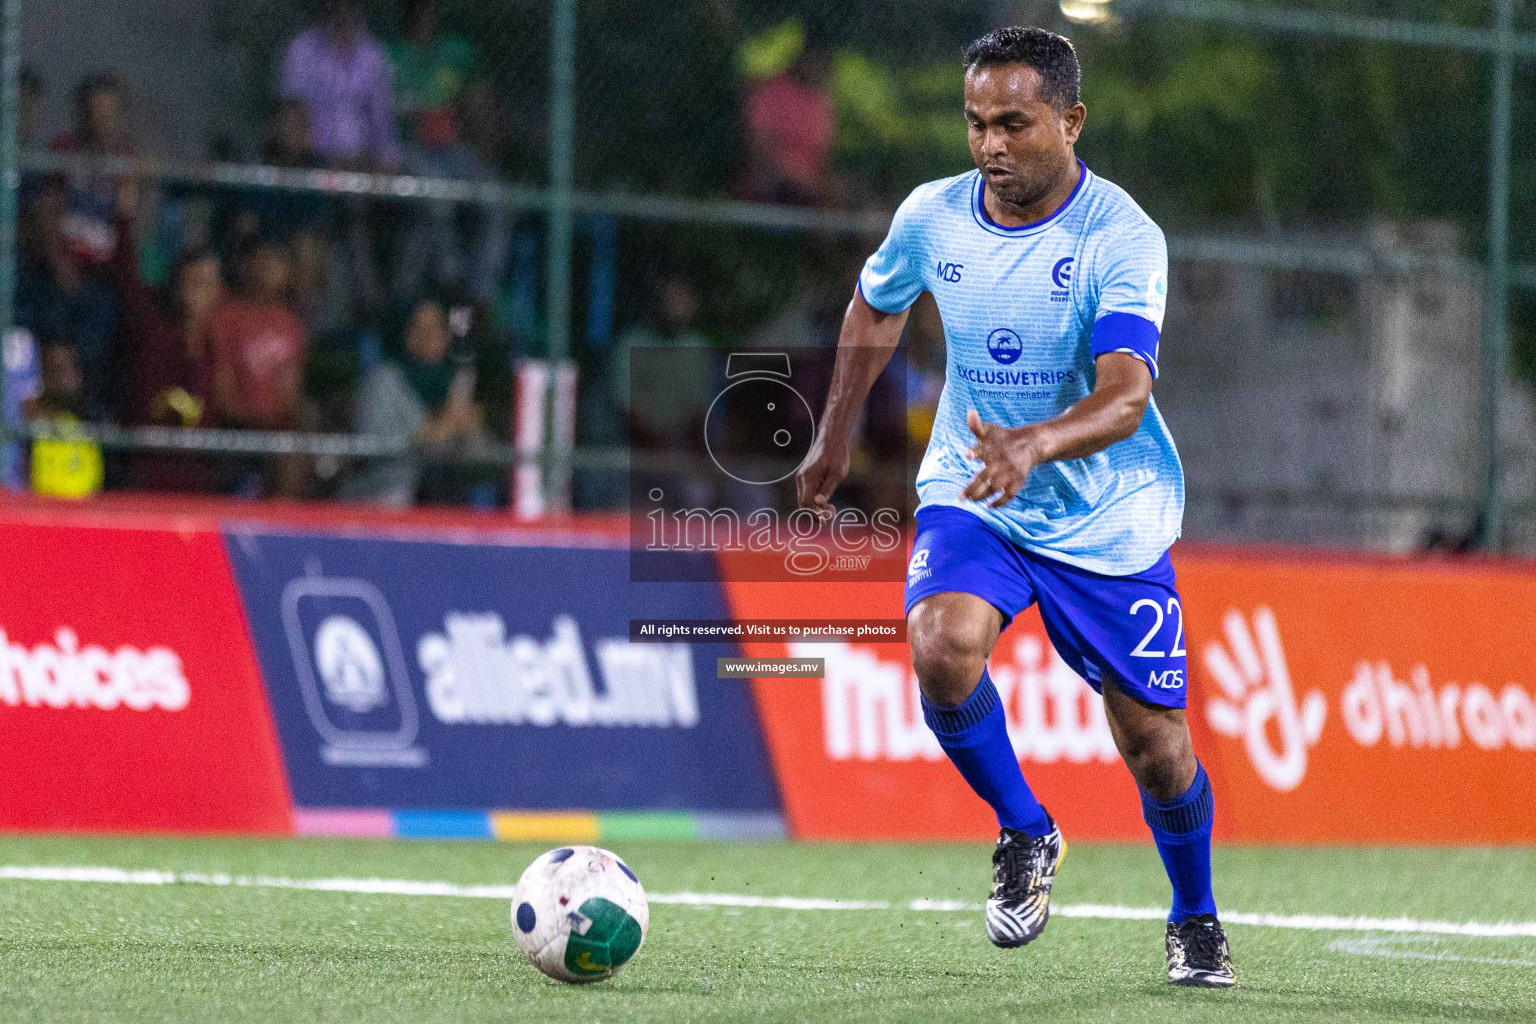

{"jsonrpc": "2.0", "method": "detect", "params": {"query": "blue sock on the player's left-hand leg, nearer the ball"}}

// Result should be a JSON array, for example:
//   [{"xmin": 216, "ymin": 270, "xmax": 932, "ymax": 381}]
[{"xmin": 923, "ymin": 668, "xmax": 1051, "ymax": 835}]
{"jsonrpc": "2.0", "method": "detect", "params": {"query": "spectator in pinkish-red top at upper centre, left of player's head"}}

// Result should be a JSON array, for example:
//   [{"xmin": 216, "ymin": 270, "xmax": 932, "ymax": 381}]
[{"xmin": 739, "ymin": 45, "xmax": 837, "ymax": 206}]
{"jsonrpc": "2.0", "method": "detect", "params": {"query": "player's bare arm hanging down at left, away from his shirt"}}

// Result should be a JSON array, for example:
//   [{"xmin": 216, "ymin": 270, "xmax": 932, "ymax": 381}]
[{"xmin": 794, "ymin": 290, "xmax": 906, "ymax": 516}]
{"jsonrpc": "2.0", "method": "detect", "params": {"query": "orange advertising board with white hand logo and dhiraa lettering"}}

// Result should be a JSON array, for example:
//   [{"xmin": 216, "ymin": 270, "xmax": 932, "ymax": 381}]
[{"xmin": 1175, "ymin": 553, "xmax": 1536, "ymax": 844}]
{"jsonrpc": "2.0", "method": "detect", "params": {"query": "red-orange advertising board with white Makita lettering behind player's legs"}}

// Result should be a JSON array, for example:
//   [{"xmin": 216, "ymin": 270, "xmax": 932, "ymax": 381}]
[{"xmin": 727, "ymin": 583, "xmax": 1144, "ymax": 840}]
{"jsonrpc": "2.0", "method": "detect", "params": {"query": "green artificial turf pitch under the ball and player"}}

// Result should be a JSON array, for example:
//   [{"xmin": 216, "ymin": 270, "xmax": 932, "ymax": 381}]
[{"xmin": 0, "ymin": 837, "xmax": 1536, "ymax": 1024}]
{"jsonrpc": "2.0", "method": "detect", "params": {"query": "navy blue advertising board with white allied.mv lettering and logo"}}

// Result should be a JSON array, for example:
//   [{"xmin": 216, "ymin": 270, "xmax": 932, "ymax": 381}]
[{"xmin": 224, "ymin": 527, "xmax": 780, "ymax": 812}]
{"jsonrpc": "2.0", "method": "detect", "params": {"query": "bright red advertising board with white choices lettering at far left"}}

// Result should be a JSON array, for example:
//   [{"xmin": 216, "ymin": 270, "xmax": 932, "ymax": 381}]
[{"xmin": 0, "ymin": 511, "xmax": 292, "ymax": 832}]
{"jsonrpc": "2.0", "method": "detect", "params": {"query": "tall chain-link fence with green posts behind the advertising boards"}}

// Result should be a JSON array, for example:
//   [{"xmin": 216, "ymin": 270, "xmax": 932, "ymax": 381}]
[{"xmin": 6, "ymin": 0, "xmax": 1536, "ymax": 551}]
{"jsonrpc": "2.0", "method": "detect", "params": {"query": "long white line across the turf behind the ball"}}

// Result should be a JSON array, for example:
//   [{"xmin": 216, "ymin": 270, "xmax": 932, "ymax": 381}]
[{"xmin": 0, "ymin": 864, "xmax": 1536, "ymax": 938}]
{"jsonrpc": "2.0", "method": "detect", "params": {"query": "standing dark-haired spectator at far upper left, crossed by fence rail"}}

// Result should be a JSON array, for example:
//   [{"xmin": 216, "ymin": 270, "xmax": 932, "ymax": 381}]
[{"xmin": 52, "ymin": 72, "xmax": 141, "ymax": 266}]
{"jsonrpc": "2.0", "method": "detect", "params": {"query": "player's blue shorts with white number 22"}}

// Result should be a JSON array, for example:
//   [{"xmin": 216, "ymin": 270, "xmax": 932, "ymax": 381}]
[{"xmin": 906, "ymin": 505, "xmax": 1189, "ymax": 708}]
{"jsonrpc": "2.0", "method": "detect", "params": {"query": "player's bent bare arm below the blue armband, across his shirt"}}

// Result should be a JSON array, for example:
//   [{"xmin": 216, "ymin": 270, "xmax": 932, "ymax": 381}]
[{"xmin": 965, "ymin": 352, "xmax": 1152, "ymax": 508}]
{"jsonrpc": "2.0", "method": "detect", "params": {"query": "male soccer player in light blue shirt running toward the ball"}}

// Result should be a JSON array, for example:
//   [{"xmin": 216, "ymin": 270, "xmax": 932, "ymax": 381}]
[{"xmin": 797, "ymin": 28, "xmax": 1235, "ymax": 987}]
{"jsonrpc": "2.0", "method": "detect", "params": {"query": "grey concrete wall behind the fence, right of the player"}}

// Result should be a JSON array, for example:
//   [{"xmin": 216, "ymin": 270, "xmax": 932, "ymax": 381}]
[{"xmin": 1157, "ymin": 226, "xmax": 1492, "ymax": 551}]
